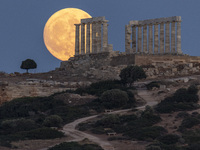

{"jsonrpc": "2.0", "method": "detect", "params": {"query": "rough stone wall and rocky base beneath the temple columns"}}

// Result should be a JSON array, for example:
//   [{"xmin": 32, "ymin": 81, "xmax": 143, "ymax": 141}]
[{"xmin": 60, "ymin": 52, "xmax": 200, "ymax": 80}]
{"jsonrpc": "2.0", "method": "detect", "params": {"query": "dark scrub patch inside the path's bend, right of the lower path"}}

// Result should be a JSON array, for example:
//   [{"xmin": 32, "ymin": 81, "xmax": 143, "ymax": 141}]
[{"xmin": 80, "ymin": 107, "xmax": 166, "ymax": 140}]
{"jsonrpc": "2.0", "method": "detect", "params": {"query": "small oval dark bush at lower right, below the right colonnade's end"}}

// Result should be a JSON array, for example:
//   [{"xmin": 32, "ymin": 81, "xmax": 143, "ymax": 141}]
[{"xmin": 158, "ymin": 134, "xmax": 179, "ymax": 145}]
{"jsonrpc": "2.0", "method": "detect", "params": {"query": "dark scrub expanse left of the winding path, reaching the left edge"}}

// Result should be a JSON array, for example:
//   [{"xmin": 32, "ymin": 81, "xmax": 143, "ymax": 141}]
[{"xmin": 0, "ymin": 96, "xmax": 89, "ymax": 147}]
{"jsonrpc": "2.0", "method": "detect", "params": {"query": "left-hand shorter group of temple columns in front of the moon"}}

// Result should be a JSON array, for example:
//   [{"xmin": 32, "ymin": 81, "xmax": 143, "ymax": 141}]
[{"xmin": 75, "ymin": 17, "xmax": 112, "ymax": 56}]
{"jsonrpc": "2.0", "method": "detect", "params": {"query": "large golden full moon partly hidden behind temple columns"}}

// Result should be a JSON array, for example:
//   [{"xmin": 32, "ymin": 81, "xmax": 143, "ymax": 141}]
[{"xmin": 43, "ymin": 8, "xmax": 91, "ymax": 61}]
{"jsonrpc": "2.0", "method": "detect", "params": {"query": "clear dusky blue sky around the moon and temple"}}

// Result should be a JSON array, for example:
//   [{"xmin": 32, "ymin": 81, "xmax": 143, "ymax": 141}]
[{"xmin": 0, "ymin": 0, "xmax": 200, "ymax": 73}]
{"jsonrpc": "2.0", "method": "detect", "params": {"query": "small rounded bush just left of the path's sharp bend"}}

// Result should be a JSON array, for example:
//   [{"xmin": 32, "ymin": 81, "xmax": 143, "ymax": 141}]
[{"xmin": 43, "ymin": 115, "xmax": 63, "ymax": 127}]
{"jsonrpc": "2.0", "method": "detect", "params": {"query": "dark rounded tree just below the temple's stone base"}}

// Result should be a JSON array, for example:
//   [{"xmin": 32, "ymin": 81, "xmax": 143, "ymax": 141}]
[{"xmin": 119, "ymin": 66, "xmax": 146, "ymax": 87}]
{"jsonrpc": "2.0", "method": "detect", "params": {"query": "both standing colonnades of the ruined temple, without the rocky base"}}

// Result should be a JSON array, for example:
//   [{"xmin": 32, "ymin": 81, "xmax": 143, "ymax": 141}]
[{"xmin": 75, "ymin": 16, "xmax": 182, "ymax": 56}]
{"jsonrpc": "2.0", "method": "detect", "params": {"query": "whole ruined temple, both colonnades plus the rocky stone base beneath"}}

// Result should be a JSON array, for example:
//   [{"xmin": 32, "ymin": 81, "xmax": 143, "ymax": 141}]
[{"xmin": 59, "ymin": 16, "xmax": 200, "ymax": 80}]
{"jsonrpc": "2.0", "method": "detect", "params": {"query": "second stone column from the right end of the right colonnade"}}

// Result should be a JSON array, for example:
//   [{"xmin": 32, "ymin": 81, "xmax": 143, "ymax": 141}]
[{"xmin": 171, "ymin": 21, "xmax": 176, "ymax": 54}]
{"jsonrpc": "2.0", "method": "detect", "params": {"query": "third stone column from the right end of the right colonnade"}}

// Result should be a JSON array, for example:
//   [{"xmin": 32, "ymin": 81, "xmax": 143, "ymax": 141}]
[{"xmin": 165, "ymin": 22, "xmax": 170, "ymax": 54}]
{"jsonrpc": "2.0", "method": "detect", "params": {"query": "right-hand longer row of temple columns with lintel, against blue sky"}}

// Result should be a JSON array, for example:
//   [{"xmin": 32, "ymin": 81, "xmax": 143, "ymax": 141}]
[{"xmin": 125, "ymin": 16, "xmax": 182, "ymax": 55}]
